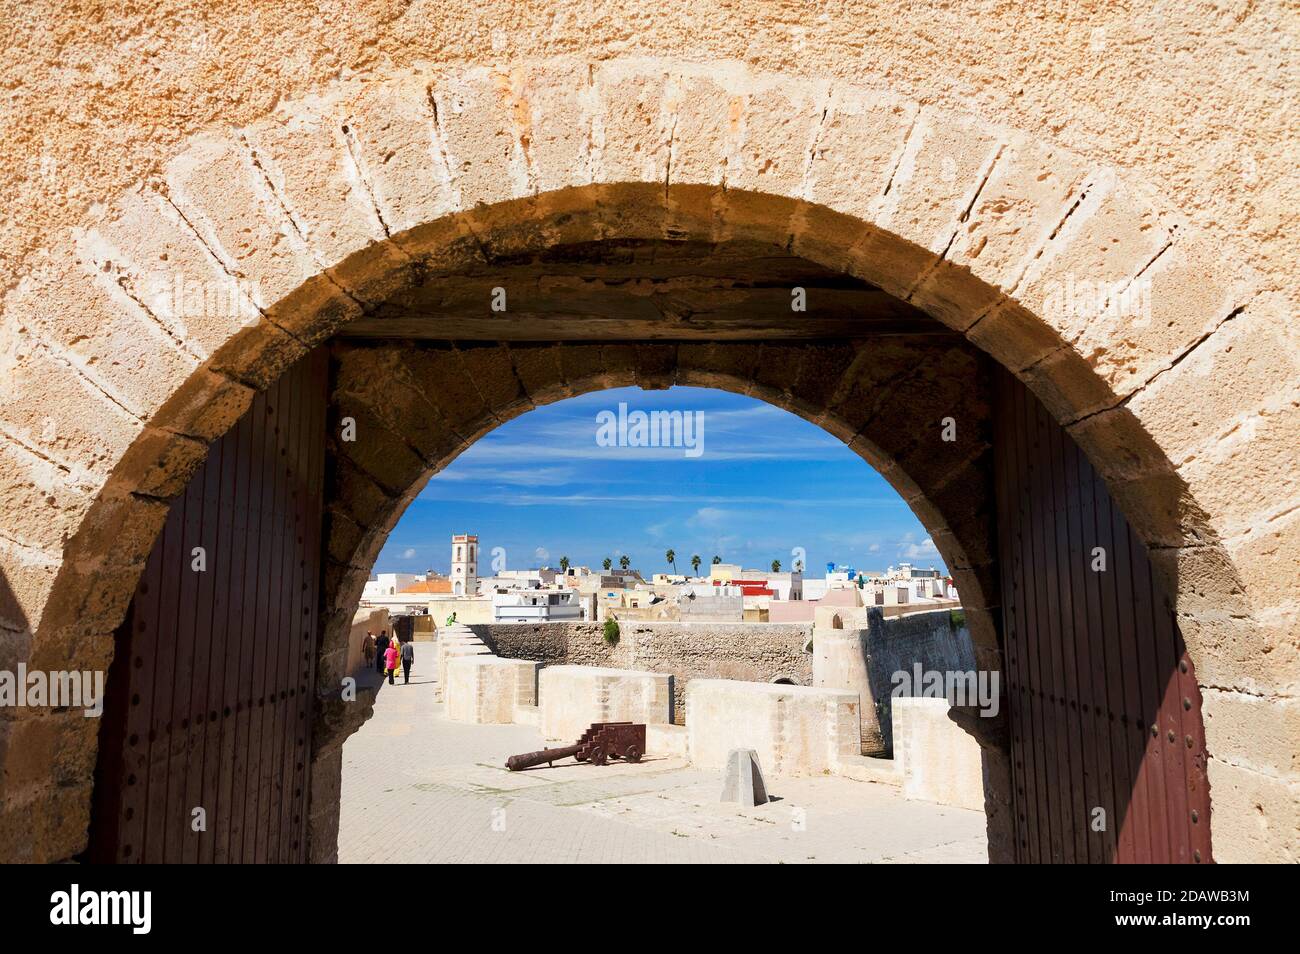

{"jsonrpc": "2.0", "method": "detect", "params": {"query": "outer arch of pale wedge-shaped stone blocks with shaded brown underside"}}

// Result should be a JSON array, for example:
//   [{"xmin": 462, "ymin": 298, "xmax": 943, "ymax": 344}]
[{"xmin": 3, "ymin": 61, "xmax": 1295, "ymax": 857}]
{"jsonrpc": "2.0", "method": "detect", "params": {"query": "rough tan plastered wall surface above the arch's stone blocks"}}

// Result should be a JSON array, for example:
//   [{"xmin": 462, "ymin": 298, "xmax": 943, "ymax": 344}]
[{"xmin": 0, "ymin": 0, "xmax": 1300, "ymax": 308}]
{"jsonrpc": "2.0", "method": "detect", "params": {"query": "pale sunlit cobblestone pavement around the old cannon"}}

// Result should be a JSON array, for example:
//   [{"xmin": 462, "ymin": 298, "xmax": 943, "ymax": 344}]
[{"xmin": 339, "ymin": 652, "xmax": 987, "ymax": 864}]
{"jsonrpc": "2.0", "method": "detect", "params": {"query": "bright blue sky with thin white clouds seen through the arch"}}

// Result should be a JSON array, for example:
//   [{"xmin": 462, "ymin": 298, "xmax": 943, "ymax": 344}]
[{"xmin": 374, "ymin": 387, "xmax": 944, "ymax": 576}]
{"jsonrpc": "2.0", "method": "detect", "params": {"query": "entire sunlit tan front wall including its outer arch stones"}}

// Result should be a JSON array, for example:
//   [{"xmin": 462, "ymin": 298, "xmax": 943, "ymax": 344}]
[{"xmin": 0, "ymin": 0, "xmax": 1300, "ymax": 860}]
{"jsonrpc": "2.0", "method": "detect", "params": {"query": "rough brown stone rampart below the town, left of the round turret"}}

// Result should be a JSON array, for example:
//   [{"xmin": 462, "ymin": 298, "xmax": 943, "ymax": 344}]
[{"xmin": 471, "ymin": 620, "xmax": 813, "ymax": 723}]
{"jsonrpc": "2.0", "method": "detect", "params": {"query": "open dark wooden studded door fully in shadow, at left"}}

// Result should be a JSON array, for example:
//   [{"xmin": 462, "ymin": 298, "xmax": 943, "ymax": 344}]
[{"xmin": 87, "ymin": 351, "xmax": 328, "ymax": 863}]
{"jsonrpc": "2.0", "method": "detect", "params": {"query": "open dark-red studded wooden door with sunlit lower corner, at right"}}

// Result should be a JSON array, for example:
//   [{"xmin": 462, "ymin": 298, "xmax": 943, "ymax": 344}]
[{"xmin": 995, "ymin": 374, "xmax": 1212, "ymax": 863}]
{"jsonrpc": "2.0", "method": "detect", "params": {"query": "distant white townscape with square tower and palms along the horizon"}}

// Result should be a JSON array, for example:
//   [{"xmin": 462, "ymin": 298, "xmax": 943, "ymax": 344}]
[{"xmin": 361, "ymin": 534, "xmax": 959, "ymax": 630}]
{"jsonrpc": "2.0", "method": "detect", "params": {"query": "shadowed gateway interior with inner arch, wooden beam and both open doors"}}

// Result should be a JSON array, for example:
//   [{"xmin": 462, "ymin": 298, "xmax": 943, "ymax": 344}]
[{"xmin": 76, "ymin": 227, "xmax": 1209, "ymax": 860}]
